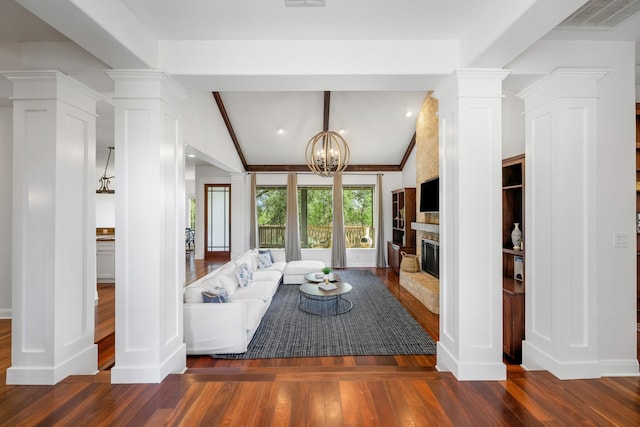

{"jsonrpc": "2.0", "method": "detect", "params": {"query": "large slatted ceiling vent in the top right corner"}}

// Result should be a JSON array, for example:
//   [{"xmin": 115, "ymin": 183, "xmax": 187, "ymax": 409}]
[{"xmin": 558, "ymin": 0, "xmax": 640, "ymax": 29}]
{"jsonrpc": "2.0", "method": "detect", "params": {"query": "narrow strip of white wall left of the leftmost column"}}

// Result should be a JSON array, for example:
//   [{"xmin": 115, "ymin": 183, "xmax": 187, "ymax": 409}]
[{"xmin": 0, "ymin": 107, "xmax": 13, "ymax": 318}]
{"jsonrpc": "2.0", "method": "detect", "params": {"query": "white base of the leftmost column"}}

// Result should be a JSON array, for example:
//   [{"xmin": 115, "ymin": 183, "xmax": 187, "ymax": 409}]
[{"xmin": 7, "ymin": 344, "xmax": 98, "ymax": 385}]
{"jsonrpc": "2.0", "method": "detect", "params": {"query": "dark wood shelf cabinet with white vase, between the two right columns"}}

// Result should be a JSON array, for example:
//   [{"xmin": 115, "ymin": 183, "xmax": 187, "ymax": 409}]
[{"xmin": 502, "ymin": 155, "xmax": 527, "ymax": 363}]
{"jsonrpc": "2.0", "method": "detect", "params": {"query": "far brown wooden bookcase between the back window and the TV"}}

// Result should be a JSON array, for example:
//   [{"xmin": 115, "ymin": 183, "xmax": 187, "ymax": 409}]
[{"xmin": 387, "ymin": 187, "xmax": 416, "ymax": 273}]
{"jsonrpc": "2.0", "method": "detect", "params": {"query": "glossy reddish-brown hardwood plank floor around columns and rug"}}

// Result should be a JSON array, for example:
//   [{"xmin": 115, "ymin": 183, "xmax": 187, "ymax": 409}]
[{"xmin": 0, "ymin": 261, "xmax": 640, "ymax": 426}]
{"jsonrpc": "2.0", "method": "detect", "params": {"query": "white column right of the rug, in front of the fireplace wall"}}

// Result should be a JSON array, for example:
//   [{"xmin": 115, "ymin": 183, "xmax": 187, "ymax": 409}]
[{"xmin": 435, "ymin": 69, "xmax": 508, "ymax": 380}]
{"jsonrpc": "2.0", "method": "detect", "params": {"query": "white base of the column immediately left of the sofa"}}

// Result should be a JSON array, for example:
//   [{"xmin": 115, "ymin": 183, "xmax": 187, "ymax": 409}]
[{"xmin": 111, "ymin": 343, "xmax": 187, "ymax": 384}]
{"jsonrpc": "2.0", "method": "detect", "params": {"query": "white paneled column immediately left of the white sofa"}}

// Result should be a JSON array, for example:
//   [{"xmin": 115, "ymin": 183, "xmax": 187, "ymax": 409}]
[{"xmin": 107, "ymin": 70, "xmax": 186, "ymax": 383}]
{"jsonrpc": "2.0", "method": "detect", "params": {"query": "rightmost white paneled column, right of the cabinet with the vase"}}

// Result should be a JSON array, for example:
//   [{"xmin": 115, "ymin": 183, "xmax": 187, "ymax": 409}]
[{"xmin": 518, "ymin": 69, "xmax": 606, "ymax": 379}]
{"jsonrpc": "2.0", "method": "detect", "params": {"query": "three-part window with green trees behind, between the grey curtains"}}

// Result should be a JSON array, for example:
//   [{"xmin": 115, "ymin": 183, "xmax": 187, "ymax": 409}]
[{"xmin": 256, "ymin": 186, "xmax": 374, "ymax": 248}]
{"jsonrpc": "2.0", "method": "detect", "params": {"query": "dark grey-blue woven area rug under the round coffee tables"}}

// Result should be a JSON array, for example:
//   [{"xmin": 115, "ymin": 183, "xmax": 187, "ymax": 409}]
[{"xmin": 211, "ymin": 270, "xmax": 436, "ymax": 359}]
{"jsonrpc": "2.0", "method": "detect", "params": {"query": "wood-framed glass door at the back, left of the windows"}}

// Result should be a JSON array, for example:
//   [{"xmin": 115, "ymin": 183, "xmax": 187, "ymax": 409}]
[{"xmin": 204, "ymin": 184, "xmax": 231, "ymax": 261}]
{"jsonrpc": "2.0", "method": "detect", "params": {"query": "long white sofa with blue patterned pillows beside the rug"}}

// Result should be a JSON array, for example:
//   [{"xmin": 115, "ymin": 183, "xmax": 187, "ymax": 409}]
[{"xmin": 184, "ymin": 249, "xmax": 287, "ymax": 355}]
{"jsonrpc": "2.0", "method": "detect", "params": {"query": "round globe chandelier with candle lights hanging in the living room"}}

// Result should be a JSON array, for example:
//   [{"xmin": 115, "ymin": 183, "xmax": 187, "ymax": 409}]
[{"xmin": 306, "ymin": 130, "xmax": 350, "ymax": 177}]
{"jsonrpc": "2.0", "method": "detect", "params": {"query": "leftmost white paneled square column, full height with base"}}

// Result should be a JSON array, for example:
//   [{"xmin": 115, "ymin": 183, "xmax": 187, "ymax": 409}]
[{"xmin": 4, "ymin": 71, "xmax": 102, "ymax": 384}]
